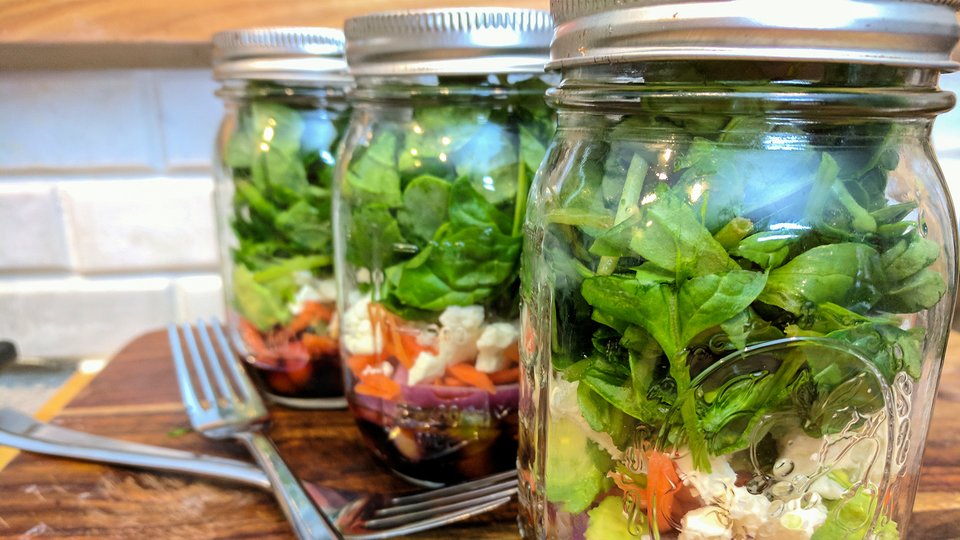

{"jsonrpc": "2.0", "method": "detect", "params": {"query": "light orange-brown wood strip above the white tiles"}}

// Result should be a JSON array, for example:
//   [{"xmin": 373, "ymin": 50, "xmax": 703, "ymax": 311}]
[{"xmin": 0, "ymin": 0, "xmax": 548, "ymax": 43}]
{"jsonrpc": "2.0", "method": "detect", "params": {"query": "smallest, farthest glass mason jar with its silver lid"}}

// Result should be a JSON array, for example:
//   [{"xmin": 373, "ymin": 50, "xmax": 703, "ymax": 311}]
[{"xmin": 213, "ymin": 28, "xmax": 351, "ymax": 408}]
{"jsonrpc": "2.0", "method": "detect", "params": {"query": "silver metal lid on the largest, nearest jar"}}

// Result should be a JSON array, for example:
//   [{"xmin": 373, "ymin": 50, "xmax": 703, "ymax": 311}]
[{"xmin": 547, "ymin": 0, "xmax": 960, "ymax": 71}]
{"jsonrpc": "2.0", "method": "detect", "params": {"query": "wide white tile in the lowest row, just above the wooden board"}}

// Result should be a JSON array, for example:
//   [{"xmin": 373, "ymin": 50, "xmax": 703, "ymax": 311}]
[{"xmin": 0, "ymin": 278, "xmax": 174, "ymax": 357}]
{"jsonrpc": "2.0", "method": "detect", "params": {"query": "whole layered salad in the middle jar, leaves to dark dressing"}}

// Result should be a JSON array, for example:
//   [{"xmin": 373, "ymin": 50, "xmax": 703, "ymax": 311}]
[{"xmin": 337, "ymin": 77, "xmax": 554, "ymax": 483}]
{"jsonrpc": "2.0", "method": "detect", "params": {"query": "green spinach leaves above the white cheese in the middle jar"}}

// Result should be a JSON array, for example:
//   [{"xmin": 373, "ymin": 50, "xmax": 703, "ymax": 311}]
[{"xmin": 342, "ymin": 78, "xmax": 554, "ymax": 319}]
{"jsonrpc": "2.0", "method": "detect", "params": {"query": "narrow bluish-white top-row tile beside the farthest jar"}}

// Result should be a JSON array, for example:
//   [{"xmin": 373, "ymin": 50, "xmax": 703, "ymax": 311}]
[{"xmin": 153, "ymin": 69, "xmax": 223, "ymax": 171}]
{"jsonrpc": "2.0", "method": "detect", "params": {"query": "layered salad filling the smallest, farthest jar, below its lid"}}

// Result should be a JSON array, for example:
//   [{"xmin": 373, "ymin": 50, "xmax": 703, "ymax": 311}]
[{"xmin": 221, "ymin": 88, "xmax": 346, "ymax": 407}]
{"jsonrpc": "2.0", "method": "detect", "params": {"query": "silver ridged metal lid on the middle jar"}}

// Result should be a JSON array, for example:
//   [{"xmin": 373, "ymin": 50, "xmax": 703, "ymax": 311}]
[{"xmin": 344, "ymin": 8, "xmax": 553, "ymax": 75}]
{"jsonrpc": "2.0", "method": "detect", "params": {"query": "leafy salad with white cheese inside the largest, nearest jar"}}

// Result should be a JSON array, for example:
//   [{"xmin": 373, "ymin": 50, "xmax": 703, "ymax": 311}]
[{"xmin": 524, "ymin": 96, "xmax": 946, "ymax": 539}]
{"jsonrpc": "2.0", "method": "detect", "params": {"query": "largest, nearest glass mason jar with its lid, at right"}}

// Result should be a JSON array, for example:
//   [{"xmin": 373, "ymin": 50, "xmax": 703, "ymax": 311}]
[{"xmin": 519, "ymin": 0, "xmax": 957, "ymax": 540}]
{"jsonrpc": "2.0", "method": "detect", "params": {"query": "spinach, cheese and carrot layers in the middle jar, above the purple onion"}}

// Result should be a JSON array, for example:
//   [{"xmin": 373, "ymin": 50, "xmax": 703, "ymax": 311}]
[{"xmin": 341, "ymin": 77, "xmax": 554, "ymax": 397}]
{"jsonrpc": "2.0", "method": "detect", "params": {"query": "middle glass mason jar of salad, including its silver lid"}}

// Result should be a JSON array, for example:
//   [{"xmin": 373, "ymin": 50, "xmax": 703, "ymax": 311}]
[{"xmin": 334, "ymin": 9, "xmax": 555, "ymax": 484}]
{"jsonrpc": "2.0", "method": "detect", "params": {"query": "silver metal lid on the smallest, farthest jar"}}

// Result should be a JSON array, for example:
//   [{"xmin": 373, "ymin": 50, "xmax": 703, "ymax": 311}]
[{"xmin": 213, "ymin": 27, "xmax": 351, "ymax": 83}]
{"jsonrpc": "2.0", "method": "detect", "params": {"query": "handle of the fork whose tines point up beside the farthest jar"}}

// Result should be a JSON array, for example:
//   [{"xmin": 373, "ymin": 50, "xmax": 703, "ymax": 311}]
[{"xmin": 235, "ymin": 431, "xmax": 343, "ymax": 540}]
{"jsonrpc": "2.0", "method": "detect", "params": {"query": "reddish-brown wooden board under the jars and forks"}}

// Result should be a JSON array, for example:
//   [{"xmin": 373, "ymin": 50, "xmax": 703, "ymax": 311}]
[{"xmin": 0, "ymin": 332, "xmax": 960, "ymax": 540}]
